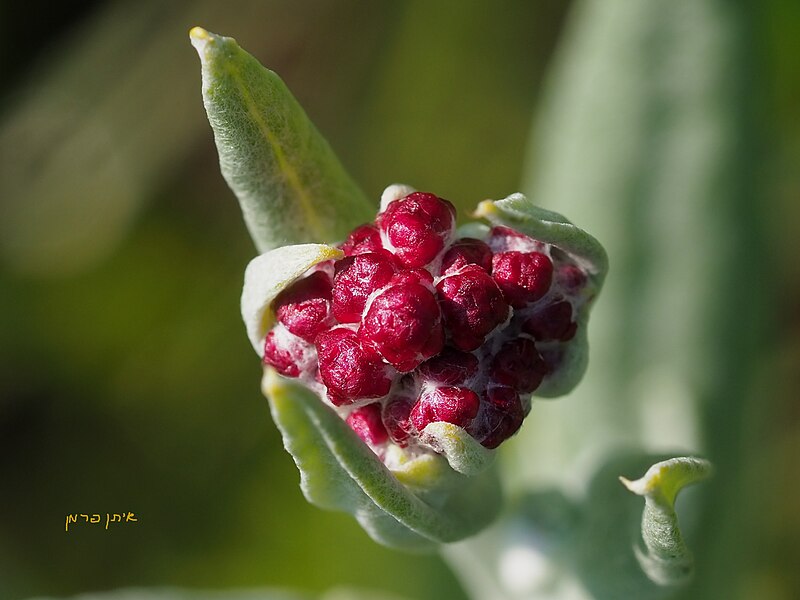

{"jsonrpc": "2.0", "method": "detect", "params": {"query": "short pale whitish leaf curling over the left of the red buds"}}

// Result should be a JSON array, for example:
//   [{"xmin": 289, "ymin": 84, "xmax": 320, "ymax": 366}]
[{"xmin": 241, "ymin": 244, "xmax": 342, "ymax": 356}]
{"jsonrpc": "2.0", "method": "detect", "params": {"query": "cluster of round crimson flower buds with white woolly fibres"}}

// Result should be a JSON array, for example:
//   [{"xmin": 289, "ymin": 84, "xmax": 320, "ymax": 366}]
[{"xmin": 264, "ymin": 186, "xmax": 587, "ymax": 457}]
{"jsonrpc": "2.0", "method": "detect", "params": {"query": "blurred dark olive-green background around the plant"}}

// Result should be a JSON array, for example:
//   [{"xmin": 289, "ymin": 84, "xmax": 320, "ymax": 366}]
[{"xmin": 0, "ymin": 0, "xmax": 800, "ymax": 600}]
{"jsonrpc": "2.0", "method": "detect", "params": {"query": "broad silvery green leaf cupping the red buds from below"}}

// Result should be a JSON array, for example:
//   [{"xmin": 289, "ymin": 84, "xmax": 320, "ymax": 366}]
[{"xmin": 262, "ymin": 367, "xmax": 501, "ymax": 550}]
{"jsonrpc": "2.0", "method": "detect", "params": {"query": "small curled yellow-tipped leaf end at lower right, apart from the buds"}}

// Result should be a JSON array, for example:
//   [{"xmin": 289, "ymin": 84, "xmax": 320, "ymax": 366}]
[{"xmin": 620, "ymin": 457, "xmax": 711, "ymax": 585}]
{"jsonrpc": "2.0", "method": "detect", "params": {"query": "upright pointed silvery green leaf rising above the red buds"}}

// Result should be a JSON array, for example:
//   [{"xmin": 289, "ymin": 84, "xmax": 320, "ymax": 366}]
[{"xmin": 190, "ymin": 27, "xmax": 375, "ymax": 252}]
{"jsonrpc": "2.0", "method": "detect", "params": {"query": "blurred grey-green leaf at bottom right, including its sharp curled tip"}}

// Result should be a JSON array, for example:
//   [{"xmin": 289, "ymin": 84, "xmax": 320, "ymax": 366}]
[{"xmin": 444, "ymin": 452, "xmax": 710, "ymax": 600}]
